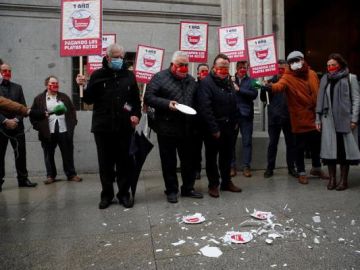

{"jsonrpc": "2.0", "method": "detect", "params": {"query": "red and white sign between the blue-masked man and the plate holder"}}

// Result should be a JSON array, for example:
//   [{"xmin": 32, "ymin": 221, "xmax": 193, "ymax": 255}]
[{"xmin": 135, "ymin": 45, "xmax": 164, "ymax": 83}]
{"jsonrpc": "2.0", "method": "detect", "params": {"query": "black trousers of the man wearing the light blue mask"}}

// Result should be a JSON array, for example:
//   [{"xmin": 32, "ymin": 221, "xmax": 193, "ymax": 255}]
[{"xmin": 94, "ymin": 132, "xmax": 134, "ymax": 201}]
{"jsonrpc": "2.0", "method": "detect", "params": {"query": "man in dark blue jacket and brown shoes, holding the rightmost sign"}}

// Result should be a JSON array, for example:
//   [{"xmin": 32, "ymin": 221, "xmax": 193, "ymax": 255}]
[{"xmin": 231, "ymin": 61, "xmax": 258, "ymax": 177}]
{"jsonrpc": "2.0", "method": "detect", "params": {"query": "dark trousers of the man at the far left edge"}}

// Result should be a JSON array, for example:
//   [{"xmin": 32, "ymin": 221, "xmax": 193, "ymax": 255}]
[{"xmin": 0, "ymin": 131, "xmax": 28, "ymax": 181}]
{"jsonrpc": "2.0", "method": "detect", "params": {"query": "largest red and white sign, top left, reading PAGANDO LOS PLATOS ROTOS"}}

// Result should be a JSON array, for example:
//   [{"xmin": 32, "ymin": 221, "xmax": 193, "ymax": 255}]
[{"xmin": 60, "ymin": 0, "xmax": 102, "ymax": 56}]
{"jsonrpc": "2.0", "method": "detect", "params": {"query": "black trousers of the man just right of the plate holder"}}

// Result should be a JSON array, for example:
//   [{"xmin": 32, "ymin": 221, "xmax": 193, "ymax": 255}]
[{"xmin": 204, "ymin": 122, "xmax": 235, "ymax": 188}]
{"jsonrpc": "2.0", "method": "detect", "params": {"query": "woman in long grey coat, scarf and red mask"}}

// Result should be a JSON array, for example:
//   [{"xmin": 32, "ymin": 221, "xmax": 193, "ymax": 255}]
[{"xmin": 316, "ymin": 53, "xmax": 360, "ymax": 190}]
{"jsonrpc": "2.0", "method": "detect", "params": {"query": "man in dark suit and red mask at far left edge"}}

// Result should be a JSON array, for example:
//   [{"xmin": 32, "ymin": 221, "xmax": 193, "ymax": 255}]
[{"xmin": 0, "ymin": 63, "xmax": 37, "ymax": 191}]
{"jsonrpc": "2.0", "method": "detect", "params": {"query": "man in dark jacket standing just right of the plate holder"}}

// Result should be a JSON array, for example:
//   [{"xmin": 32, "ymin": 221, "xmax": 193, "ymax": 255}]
[{"xmin": 197, "ymin": 54, "xmax": 241, "ymax": 198}]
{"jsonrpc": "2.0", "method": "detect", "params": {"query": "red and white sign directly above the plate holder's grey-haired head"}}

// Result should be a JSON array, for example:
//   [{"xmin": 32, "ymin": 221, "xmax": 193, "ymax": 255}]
[{"xmin": 179, "ymin": 22, "xmax": 209, "ymax": 63}]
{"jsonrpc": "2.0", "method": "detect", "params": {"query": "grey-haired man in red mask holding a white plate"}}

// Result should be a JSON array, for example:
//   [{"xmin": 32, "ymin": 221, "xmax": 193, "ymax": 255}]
[{"xmin": 144, "ymin": 51, "xmax": 203, "ymax": 203}]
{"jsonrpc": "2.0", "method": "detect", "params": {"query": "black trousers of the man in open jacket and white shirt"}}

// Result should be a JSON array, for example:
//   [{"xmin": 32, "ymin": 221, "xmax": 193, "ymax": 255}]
[{"xmin": 41, "ymin": 130, "xmax": 76, "ymax": 179}]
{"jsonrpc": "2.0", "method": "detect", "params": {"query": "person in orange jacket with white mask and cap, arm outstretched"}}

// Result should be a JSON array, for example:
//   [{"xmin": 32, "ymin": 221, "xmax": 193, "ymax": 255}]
[{"xmin": 267, "ymin": 51, "xmax": 328, "ymax": 184}]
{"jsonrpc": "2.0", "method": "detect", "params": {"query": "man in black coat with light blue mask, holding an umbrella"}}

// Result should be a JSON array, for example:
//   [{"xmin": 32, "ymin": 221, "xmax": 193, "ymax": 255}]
[{"xmin": 76, "ymin": 44, "xmax": 141, "ymax": 209}]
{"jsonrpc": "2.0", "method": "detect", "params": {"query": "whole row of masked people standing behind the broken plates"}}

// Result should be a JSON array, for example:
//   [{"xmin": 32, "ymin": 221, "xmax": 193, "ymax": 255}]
[{"xmin": 0, "ymin": 44, "xmax": 360, "ymax": 209}]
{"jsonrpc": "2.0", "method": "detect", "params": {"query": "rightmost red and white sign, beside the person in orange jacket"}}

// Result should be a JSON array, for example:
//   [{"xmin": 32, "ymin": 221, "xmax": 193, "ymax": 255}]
[{"xmin": 246, "ymin": 34, "xmax": 279, "ymax": 78}]
